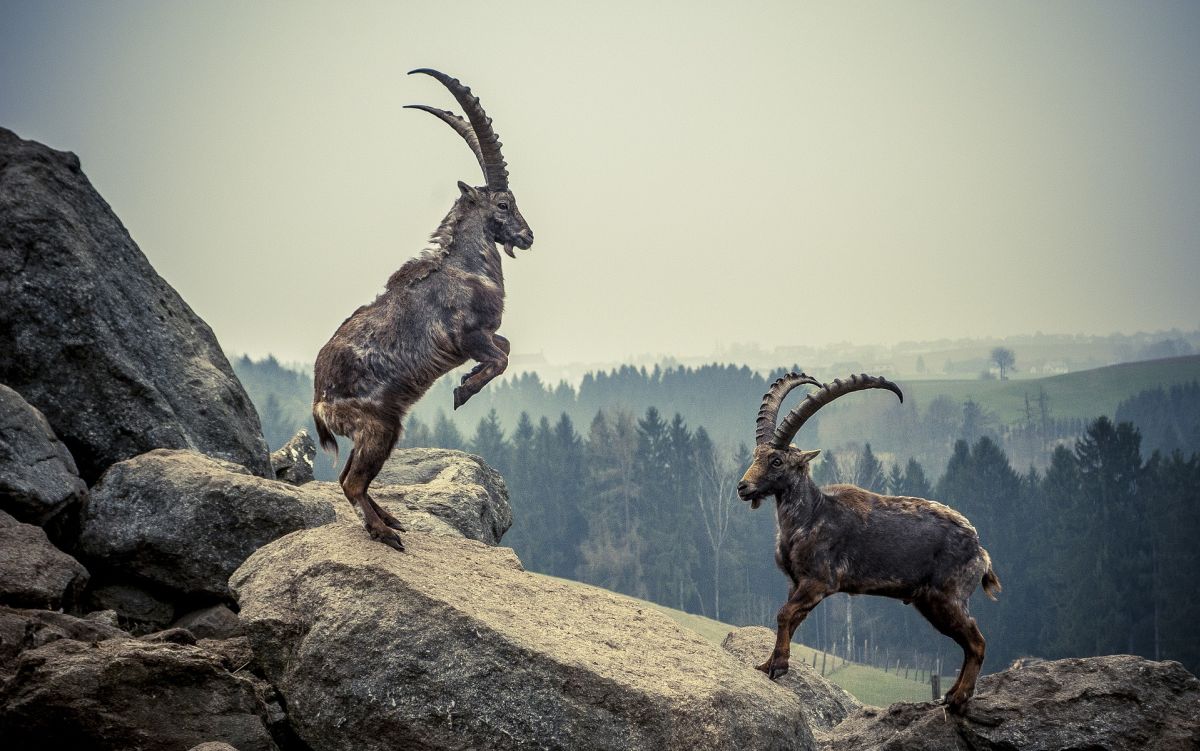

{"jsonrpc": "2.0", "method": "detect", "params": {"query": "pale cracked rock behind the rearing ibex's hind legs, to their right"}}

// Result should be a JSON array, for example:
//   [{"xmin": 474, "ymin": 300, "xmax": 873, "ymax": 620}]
[{"xmin": 372, "ymin": 449, "xmax": 512, "ymax": 545}]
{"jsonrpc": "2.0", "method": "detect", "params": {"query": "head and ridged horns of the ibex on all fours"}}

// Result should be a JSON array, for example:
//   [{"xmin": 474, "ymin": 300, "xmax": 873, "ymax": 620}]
[{"xmin": 738, "ymin": 373, "xmax": 904, "ymax": 509}]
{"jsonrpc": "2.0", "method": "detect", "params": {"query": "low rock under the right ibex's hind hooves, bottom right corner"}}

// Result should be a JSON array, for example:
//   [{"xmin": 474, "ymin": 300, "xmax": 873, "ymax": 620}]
[{"xmin": 823, "ymin": 655, "xmax": 1200, "ymax": 751}]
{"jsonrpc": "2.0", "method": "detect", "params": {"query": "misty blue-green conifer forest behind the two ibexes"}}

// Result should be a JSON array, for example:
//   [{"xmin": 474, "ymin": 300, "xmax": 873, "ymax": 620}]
[{"xmin": 235, "ymin": 358, "xmax": 1200, "ymax": 672}]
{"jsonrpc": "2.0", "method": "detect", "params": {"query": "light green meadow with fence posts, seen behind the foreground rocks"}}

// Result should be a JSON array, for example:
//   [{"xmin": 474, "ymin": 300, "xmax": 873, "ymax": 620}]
[{"xmin": 539, "ymin": 575, "xmax": 931, "ymax": 707}]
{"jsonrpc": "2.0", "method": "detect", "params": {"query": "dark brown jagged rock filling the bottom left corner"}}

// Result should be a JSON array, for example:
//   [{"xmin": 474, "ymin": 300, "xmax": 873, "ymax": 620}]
[{"xmin": 0, "ymin": 638, "xmax": 276, "ymax": 751}]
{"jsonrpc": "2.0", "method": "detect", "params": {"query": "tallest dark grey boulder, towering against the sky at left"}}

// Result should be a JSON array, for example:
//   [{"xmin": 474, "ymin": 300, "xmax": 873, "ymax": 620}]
[{"xmin": 0, "ymin": 128, "xmax": 274, "ymax": 483}]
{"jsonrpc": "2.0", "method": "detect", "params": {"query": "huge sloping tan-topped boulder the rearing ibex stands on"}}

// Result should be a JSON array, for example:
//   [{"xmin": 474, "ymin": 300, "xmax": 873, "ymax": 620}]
[{"xmin": 230, "ymin": 523, "xmax": 812, "ymax": 751}]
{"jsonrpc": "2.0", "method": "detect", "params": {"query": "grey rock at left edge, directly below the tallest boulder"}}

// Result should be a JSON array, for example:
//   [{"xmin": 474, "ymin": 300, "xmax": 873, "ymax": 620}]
[{"xmin": 0, "ymin": 384, "xmax": 88, "ymax": 525}]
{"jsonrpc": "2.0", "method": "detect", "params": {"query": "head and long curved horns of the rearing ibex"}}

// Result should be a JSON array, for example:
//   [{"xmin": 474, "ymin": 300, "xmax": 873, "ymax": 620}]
[{"xmin": 408, "ymin": 68, "xmax": 533, "ymax": 258}]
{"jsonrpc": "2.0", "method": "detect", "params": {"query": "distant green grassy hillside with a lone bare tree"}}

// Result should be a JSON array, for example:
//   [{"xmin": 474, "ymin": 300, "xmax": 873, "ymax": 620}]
[{"xmin": 904, "ymin": 355, "xmax": 1200, "ymax": 423}]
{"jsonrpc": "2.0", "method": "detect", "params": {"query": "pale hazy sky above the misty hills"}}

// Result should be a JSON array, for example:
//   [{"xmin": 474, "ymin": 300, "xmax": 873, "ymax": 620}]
[{"xmin": 0, "ymin": 0, "xmax": 1200, "ymax": 362}]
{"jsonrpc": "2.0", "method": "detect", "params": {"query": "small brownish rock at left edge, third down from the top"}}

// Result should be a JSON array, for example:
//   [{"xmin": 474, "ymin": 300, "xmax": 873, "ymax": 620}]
[{"xmin": 0, "ymin": 511, "xmax": 88, "ymax": 609}]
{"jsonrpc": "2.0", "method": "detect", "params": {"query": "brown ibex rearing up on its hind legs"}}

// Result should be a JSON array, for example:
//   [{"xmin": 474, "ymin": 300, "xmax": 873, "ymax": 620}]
[{"xmin": 312, "ymin": 68, "xmax": 533, "ymax": 551}]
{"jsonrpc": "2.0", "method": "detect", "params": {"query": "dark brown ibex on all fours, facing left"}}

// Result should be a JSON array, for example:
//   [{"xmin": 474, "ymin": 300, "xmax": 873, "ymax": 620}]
[{"xmin": 738, "ymin": 373, "xmax": 1000, "ymax": 710}]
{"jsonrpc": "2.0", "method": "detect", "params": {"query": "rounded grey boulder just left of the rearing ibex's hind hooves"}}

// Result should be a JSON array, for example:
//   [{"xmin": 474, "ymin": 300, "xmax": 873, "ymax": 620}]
[{"xmin": 79, "ymin": 449, "xmax": 335, "ymax": 597}]
